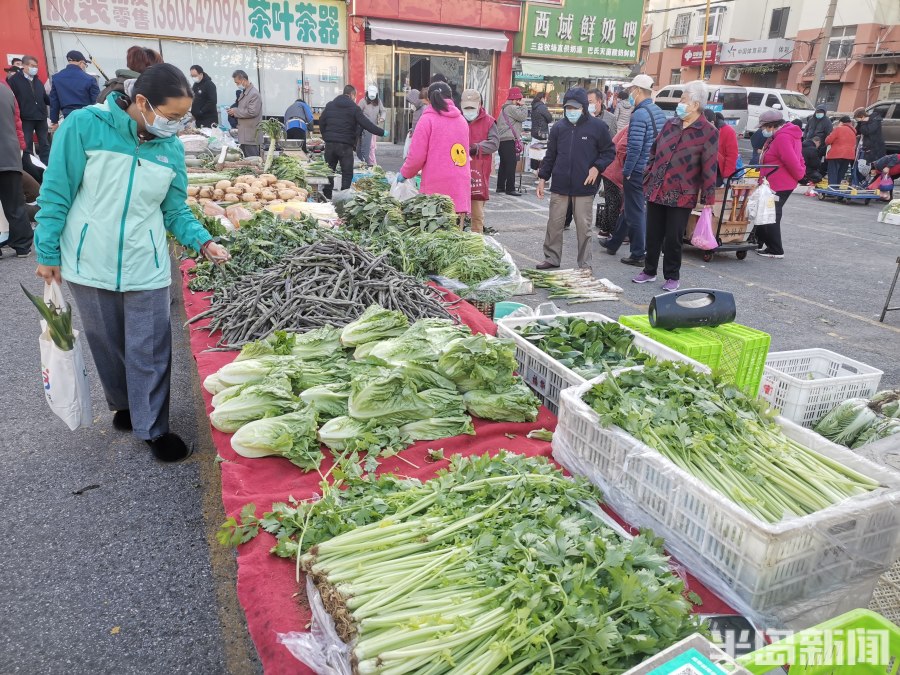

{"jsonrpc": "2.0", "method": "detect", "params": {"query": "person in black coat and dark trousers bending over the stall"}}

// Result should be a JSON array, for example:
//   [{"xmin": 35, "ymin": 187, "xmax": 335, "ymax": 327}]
[{"xmin": 319, "ymin": 84, "xmax": 390, "ymax": 199}]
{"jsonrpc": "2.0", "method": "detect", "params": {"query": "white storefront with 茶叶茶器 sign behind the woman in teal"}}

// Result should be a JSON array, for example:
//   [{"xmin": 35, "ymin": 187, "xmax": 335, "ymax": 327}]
[{"xmin": 40, "ymin": 0, "xmax": 347, "ymax": 116}]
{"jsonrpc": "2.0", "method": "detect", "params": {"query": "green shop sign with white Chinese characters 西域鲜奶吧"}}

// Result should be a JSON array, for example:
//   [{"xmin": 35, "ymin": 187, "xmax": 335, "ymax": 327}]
[{"xmin": 516, "ymin": 0, "xmax": 644, "ymax": 63}]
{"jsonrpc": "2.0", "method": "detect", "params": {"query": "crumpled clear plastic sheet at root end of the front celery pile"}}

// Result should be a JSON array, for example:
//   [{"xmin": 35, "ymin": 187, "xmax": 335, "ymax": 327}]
[{"xmin": 278, "ymin": 577, "xmax": 353, "ymax": 675}]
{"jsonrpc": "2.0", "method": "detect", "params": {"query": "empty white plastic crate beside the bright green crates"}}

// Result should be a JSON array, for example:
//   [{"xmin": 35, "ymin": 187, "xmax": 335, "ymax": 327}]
[{"xmin": 760, "ymin": 349, "xmax": 884, "ymax": 428}]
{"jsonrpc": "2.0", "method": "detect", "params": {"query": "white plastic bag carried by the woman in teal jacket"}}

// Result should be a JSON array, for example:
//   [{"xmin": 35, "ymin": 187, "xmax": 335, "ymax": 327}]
[{"xmin": 38, "ymin": 281, "xmax": 91, "ymax": 431}]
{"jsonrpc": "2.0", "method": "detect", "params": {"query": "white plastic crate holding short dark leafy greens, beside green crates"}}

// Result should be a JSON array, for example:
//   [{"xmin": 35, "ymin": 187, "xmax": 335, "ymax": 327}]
[{"xmin": 497, "ymin": 312, "xmax": 709, "ymax": 415}]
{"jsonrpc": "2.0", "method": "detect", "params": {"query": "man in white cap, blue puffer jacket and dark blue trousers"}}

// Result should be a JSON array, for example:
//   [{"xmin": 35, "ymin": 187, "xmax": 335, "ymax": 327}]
[{"xmin": 600, "ymin": 75, "xmax": 666, "ymax": 267}]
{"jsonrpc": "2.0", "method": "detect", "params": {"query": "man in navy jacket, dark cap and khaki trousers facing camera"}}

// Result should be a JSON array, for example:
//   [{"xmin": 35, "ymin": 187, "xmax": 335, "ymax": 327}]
[{"xmin": 537, "ymin": 87, "xmax": 616, "ymax": 270}]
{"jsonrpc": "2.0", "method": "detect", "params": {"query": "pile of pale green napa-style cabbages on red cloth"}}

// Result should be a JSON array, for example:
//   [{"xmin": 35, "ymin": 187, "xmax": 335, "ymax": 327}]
[{"xmin": 203, "ymin": 305, "xmax": 540, "ymax": 470}]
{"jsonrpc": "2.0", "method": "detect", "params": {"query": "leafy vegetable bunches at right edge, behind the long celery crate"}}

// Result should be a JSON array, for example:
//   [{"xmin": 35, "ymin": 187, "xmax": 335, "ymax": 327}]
[{"xmin": 814, "ymin": 390, "xmax": 900, "ymax": 449}]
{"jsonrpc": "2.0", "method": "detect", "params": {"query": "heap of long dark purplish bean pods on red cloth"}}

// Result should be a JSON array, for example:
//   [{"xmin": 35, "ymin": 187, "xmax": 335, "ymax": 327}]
[{"xmin": 190, "ymin": 235, "xmax": 453, "ymax": 348}]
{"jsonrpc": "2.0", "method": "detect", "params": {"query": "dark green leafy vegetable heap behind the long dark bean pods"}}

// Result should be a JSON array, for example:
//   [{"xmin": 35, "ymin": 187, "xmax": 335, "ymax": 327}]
[{"xmin": 188, "ymin": 209, "xmax": 319, "ymax": 291}]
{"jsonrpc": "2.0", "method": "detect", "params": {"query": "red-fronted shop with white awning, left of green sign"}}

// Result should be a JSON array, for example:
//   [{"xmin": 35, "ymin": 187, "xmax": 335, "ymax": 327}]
[{"xmin": 349, "ymin": 0, "xmax": 521, "ymax": 143}]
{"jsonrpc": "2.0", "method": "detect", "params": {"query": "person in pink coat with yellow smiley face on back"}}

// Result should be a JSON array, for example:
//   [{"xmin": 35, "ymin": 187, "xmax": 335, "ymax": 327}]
[{"xmin": 400, "ymin": 82, "xmax": 472, "ymax": 214}]
